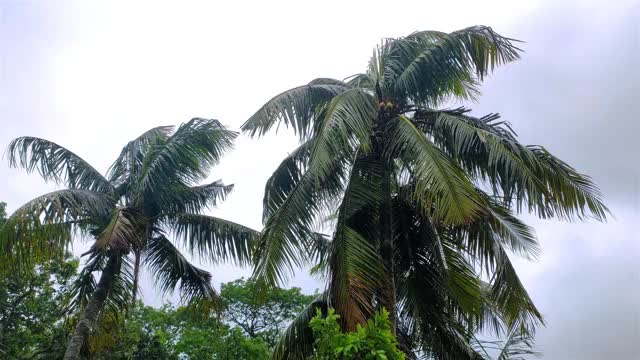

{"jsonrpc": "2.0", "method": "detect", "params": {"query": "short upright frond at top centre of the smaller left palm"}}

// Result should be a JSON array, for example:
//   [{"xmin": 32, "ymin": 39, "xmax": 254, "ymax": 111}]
[{"xmin": 107, "ymin": 126, "xmax": 174, "ymax": 185}]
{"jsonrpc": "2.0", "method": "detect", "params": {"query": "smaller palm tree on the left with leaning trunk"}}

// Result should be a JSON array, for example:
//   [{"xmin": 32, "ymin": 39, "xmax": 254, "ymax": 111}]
[{"xmin": 0, "ymin": 118, "xmax": 256, "ymax": 359}]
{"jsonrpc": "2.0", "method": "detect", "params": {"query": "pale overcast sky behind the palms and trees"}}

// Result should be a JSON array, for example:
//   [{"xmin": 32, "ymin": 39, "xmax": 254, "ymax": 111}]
[{"xmin": 0, "ymin": 0, "xmax": 640, "ymax": 360}]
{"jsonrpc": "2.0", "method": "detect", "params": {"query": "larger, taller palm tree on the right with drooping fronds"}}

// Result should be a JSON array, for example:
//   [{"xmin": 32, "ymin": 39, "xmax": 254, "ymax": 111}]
[{"xmin": 242, "ymin": 26, "xmax": 608, "ymax": 359}]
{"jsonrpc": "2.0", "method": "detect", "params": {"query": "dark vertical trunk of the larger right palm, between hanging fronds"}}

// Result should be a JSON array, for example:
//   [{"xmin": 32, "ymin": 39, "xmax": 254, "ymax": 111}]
[{"xmin": 380, "ymin": 164, "xmax": 396, "ymax": 335}]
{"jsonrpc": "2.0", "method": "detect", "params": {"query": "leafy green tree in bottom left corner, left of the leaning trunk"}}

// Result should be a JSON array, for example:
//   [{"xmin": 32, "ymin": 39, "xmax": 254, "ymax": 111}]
[{"xmin": 0, "ymin": 252, "xmax": 78, "ymax": 359}]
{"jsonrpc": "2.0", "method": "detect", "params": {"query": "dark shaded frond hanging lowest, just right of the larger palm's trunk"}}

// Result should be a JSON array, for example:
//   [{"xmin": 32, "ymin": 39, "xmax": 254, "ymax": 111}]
[{"xmin": 394, "ymin": 197, "xmax": 484, "ymax": 359}]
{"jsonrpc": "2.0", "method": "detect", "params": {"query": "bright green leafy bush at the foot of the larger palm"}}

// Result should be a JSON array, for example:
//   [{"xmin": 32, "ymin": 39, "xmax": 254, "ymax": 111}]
[{"xmin": 309, "ymin": 309, "xmax": 405, "ymax": 360}]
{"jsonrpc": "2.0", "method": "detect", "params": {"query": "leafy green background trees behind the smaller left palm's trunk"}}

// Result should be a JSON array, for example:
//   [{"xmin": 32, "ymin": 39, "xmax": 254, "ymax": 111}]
[{"xmin": 0, "ymin": 233, "xmax": 314, "ymax": 360}]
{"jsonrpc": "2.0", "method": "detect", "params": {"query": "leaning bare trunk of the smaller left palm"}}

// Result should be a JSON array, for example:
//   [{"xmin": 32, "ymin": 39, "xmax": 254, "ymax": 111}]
[{"xmin": 63, "ymin": 255, "xmax": 120, "ymax": 360}]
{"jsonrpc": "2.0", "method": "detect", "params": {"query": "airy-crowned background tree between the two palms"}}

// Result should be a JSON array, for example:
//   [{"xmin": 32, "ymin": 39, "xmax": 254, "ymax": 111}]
[{"xmin": 220, "ymin": 279, "xmax": 315, "ymax": 347}]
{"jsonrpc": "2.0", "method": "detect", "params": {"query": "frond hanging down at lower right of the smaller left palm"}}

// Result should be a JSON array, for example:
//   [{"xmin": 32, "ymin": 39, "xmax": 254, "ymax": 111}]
[{"xmin": 143, "ymin": 235, "xmax": 219, "ymax": 302}]
